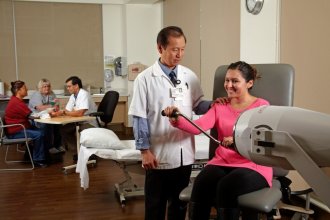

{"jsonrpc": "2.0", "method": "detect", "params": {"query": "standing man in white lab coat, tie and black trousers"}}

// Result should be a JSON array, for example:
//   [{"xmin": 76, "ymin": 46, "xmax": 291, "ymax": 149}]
[{"xmin": 129, "ymin": 26, "xmax": 211, "ymax": 220}]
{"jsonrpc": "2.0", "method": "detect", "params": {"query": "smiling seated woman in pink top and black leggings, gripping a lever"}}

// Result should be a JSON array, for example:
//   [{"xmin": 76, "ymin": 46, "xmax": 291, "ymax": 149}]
[{"xmin": 165, "ymin": 61, "xmax": 273, "ymax": 220}]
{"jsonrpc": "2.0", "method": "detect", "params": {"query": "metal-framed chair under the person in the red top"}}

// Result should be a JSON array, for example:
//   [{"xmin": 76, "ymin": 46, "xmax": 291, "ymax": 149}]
[{"xmin": 0, "ymin": 113, "xmax": 34, "ymax": 171}]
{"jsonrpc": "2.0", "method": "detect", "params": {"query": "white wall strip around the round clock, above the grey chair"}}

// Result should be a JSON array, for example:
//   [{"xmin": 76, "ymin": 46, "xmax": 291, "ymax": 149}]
[{"xmin": 240, "ymin": 0, "xmax": 281, "ymax": 63}]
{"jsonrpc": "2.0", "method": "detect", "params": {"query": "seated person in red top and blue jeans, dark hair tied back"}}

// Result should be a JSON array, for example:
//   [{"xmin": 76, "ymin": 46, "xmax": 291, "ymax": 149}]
[{"xmin": 4, "ymin": 80, "xmax": 47, "ymax": 167}]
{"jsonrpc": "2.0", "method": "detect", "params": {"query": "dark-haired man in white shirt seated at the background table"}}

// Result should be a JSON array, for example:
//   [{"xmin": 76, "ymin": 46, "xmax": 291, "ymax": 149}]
[{"xmin": 50, "ymin": 76, "xmax": 97, "ymax": 161}]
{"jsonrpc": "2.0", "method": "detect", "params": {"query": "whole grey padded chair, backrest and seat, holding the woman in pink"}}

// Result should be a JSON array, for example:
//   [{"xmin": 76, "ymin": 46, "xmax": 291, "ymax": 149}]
[{"xmin": 180, "ymin": 64, "xmax": 312, "ymax": 219}]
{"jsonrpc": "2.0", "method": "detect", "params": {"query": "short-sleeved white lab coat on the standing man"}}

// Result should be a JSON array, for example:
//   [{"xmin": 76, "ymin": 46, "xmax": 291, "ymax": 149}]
[{"xmin": 128, "ymin": 61, "xmax": 203, "ymax": 169}]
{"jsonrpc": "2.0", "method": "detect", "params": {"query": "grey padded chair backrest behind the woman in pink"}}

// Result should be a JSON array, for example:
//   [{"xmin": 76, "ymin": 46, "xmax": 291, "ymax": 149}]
[{"xmin": 209, "ymin": 64, "xmax": 294, "ymax": 158}]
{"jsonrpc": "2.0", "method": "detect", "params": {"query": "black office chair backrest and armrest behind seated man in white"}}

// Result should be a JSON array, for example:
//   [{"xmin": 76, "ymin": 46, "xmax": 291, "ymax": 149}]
[{"xmin": 90, "ymin": 91, "xmax": 119, "ymax": 128}]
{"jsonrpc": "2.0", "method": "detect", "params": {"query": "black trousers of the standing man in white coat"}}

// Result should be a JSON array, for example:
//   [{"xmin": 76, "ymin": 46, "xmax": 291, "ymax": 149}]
[{"xmin": 144, "ymin": 165, "xmax": 191, "ymax": 220}]
